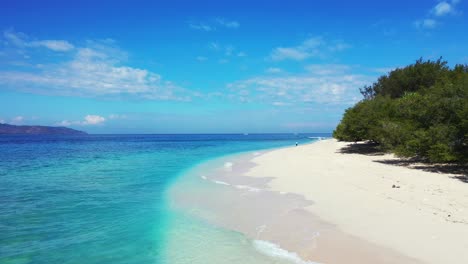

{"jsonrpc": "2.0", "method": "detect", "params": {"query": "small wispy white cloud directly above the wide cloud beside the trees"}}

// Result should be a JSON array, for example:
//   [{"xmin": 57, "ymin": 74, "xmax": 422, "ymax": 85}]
[{"xmin": 270, "ymin": 37, "xmax": 351, "ymax": 61}]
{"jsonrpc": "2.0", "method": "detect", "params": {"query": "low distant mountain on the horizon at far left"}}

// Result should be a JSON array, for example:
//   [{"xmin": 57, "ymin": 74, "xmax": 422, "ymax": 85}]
[{"xmin": 0, "ymin": 124, "xmax": 87, "ymax": 135}]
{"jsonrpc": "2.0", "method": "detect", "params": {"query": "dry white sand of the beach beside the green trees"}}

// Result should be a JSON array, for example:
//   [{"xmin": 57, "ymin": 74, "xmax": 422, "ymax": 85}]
[{"xmin": 243, "ymin": 140, "xmax": 468, "ymax": 263}]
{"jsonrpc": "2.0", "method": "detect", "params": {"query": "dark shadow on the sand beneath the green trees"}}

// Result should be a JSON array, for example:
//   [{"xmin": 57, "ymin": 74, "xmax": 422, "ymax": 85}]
[{"xmin": 339, "ymin": 142, "xmax": 468, "ymax": 183}]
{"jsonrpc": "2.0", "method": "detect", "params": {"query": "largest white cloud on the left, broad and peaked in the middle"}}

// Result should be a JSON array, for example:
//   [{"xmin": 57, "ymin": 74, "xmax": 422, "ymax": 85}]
[{"xmin": 0, "ymin": 41, "xmax": 192, "ymax": 100}]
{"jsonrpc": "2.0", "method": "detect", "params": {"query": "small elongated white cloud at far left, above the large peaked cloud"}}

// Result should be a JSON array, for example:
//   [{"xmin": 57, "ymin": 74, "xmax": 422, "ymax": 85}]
[{"xmin": 3, "ymin": 30, "xmax": 75, "ymax": 52}]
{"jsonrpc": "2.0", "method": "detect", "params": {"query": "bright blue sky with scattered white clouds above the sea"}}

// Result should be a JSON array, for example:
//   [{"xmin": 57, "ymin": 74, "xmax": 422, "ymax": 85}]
[{"xmin": 0, "ymin": 0, "xmax": 468, "ymax": 133}]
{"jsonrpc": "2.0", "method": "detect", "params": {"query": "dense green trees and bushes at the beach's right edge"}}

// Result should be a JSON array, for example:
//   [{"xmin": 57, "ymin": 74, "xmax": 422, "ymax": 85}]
[{"xmin": 333, "ymin": 59, "xmax": 468, "ymax": 162}]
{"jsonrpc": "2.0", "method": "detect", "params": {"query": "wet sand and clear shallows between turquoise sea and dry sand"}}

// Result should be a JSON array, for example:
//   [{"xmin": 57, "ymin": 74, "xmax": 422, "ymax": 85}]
[{"xmin": 170, "ymin": 141, "xmax": 432, "ymax": 263}]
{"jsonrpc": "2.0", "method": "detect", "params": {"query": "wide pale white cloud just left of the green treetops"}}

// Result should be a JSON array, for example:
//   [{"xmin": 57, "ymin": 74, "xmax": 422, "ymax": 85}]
[{"xmin": 228, "ymin": 65, "xmax": 373, "ymax": 106}]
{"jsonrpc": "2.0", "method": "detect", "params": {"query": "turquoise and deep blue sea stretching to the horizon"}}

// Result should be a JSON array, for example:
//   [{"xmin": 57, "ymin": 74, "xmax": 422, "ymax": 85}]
[{"xmin": 0, "ymin": 134, "xmax": 330, "ymax": 264}]
